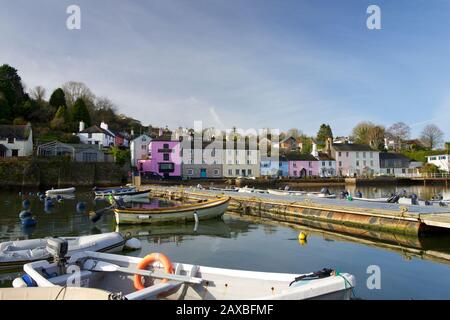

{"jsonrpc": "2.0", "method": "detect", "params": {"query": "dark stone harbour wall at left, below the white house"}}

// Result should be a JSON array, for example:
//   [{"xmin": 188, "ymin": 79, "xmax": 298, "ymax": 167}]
[{"xmin": 0, "ymin": 158, "xmax": 127, "ymax": 188}]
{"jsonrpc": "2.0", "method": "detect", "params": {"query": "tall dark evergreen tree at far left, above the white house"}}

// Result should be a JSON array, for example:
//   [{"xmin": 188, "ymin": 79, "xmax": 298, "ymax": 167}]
[{"xmin": 0, "ymin": 64, "xmax": 27, "ymax": 119}]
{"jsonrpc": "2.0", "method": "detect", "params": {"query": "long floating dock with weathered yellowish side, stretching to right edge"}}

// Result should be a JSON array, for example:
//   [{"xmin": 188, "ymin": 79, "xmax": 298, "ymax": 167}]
[{"xmin": 148, "ymin": 186, "xmax": 450, "ymax": 236}]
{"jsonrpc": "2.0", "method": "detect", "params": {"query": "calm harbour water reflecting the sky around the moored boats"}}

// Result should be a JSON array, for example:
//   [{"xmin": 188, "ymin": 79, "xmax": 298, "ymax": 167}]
[{"xmin": 0, "ymin": 187, "xmax": 450, "ymax": 299}]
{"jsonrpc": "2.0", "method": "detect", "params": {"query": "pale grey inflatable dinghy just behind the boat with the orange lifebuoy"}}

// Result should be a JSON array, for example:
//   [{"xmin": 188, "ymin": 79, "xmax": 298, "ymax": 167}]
[{"xmin": 0, "ymin": 232, "xmax": 126, "ymax": 270}]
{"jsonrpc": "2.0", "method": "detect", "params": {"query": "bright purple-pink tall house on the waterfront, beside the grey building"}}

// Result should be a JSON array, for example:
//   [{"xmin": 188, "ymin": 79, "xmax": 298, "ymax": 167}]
[{"xmin": 138, "ymin": 136, "xmax": 181, "ymax": 178}]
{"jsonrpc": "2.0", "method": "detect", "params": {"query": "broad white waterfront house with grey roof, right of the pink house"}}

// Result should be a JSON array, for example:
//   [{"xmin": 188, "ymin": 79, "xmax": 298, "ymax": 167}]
[{"xmin": 331, "ymin": 143, "xmax": 380, "ymax": 177}]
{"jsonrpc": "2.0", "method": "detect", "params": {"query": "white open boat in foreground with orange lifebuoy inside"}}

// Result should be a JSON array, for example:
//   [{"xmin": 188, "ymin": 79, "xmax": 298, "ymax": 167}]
[{"xmin": 14, "ymin": 252, "xmax": 355, "ymax": 300}]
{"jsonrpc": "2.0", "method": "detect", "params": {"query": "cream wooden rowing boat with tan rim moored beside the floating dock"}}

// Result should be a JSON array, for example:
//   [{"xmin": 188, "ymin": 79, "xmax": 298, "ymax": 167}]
[{"xmin": 114, "ymin": 197, "xmax": 230, "ymax": 224}]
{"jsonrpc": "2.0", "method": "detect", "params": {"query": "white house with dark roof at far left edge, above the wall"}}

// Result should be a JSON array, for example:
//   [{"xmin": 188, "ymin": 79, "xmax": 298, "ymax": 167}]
[{"xmin": 0, "ymin": 123, "xmax": 33, "ymax": 158}]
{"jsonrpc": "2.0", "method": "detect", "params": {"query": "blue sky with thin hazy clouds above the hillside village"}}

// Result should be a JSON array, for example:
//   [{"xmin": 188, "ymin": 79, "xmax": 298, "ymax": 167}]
[{"xmin": 0, "ymin": 0, "xmax": 450, "ymax": 140}]
